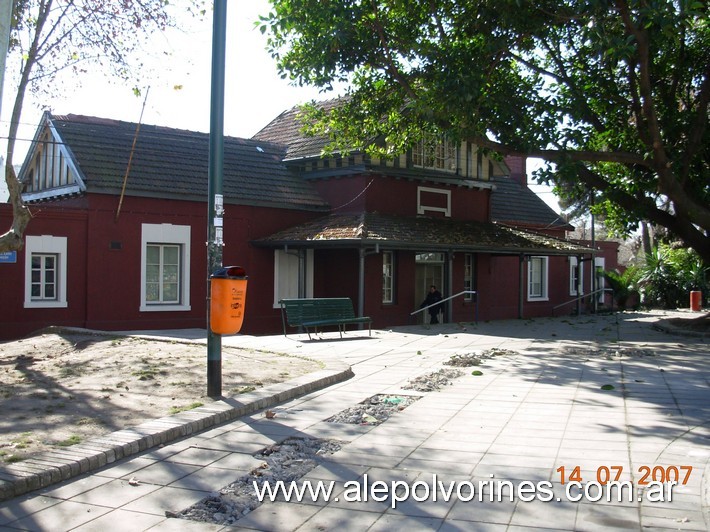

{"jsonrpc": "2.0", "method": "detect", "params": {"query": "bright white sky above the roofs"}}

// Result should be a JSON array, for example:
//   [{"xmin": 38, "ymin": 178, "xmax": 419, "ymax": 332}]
[{"xmin": 0, "ymin": 0, "xmax": 559, "ymax": 211}]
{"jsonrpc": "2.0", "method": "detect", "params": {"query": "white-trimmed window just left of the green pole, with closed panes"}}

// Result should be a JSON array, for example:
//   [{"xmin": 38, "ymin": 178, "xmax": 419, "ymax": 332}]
[{"xmin": 140, "ymin": 224, "xmax": 190, "ymax": 312}]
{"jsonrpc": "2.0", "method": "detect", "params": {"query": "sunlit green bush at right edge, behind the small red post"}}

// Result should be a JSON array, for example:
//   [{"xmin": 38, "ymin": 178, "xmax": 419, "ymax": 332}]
[{"xmin": 638, "ymin": 244, "xmax": 710, "ymax": 308}]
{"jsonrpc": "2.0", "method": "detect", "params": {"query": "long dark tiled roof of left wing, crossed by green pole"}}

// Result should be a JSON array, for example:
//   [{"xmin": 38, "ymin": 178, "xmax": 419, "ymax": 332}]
[{"xmin": 50, "ymin": 115, "xmax": 327, "ymax": 210}]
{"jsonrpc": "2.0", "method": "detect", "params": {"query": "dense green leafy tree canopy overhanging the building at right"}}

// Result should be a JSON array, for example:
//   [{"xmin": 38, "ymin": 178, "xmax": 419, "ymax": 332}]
[{"xmin": 257, "ymin": 0, "xmax": 710, "ymax": 263}]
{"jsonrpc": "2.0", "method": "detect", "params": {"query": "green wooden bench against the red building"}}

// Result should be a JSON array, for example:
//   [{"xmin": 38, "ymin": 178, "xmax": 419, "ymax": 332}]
[{"xmin": 279, "ymin": 297, "xmax": 372, "ymax": 339}]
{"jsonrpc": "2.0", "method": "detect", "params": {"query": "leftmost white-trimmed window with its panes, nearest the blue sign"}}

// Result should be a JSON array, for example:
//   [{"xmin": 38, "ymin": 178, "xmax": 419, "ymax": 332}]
[{"xmin": 24, "ymin": 235, "xmax": 67, "ymax": 308}]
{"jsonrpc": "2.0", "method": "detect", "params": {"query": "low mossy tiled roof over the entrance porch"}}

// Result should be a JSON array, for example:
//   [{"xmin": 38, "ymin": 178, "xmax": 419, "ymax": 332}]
[{"xmin": 254, "ymin": 213, "xmax": 592, "ymax": 255}]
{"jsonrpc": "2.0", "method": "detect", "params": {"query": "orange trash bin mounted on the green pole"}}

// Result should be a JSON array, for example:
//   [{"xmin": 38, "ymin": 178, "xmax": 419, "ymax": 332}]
[{"xmin": 210, "ymin": 266, "xmax": 247, "ymax": 334}]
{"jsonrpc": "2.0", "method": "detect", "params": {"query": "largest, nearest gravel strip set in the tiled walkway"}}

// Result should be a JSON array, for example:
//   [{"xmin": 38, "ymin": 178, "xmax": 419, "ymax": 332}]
[{"xmin": 174, "ymin": 438, "xmax": 344, "ymax": 525}]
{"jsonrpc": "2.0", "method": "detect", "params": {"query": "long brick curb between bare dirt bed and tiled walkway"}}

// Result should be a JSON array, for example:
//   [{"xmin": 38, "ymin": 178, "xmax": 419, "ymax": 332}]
[{"xmin": 0, "ymin": 363, "xmax": 353, "ymax": 501}]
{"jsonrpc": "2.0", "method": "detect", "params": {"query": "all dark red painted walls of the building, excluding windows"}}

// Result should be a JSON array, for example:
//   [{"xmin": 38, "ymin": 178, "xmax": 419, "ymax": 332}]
[{"xmin": 0, "ymin": 176, "xmax": 616, "ymax": 339}]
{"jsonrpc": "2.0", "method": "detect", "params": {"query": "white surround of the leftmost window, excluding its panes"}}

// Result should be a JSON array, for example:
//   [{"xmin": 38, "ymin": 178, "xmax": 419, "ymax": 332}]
[{"xmin": 24, "ymin": 235, "xmax": 69, "ymax": 308}]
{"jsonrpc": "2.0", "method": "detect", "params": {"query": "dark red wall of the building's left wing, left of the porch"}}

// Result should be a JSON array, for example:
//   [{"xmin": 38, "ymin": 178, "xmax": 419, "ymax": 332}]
[{"xmin": 0, "ymin": 195, "xmax": 321, "ymax": 339}]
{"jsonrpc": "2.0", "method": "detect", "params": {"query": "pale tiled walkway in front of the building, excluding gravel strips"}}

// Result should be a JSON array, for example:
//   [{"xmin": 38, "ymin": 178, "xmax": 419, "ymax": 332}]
[{"xmin": 0, "ymin": 313, "xmax": 710, "ymax": 531}]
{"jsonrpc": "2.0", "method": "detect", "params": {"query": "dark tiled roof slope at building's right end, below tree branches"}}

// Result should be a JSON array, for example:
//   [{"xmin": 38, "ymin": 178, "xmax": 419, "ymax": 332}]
[{"xmin": 491, "ymin": 177, "xmax": 572, "ymax": 230}]
